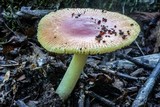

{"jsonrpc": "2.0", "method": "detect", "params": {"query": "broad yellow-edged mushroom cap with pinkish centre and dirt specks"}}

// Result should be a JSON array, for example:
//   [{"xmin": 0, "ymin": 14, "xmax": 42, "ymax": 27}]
[{"xmin": 37, "ymin": 8, "xmax": 140, "ymax": 54}]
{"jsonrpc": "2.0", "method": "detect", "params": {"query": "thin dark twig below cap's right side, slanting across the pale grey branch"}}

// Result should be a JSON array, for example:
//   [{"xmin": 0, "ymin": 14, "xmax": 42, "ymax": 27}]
[{"xmin": 118, "ymin": 54, "xmax": 153, "ymax": 69}]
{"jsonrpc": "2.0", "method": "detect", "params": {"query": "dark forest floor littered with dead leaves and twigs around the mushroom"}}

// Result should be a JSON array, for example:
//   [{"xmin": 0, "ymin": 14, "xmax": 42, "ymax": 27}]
[{"xmin": 0, "ymin": 0, "xmax": 160, "ymax": 107}]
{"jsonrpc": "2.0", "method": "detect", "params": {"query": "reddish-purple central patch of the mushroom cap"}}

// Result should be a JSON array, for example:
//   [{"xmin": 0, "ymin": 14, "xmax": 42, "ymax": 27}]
[{"xmin": 62, "ymin": 16, "xmax": 99, "ymax": 37}]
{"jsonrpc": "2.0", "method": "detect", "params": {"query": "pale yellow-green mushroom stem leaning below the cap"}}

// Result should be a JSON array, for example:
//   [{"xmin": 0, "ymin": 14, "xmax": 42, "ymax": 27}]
[{"xmin": 56, "ymin": 54, "xmax": 88, "ymax": 101}]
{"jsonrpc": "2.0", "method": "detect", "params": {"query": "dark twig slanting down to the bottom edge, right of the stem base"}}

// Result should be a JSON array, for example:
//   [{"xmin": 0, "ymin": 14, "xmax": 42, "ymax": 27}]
[{"xmin": 86, "ymin": 91, "xmax": 115, "ymax": 107}]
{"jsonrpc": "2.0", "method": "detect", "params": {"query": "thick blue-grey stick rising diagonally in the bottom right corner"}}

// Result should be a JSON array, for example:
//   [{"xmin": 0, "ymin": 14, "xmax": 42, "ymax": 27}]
[{"xmin": 132, "ymin": 59, "xmax": 160, "ymax": 107}]
